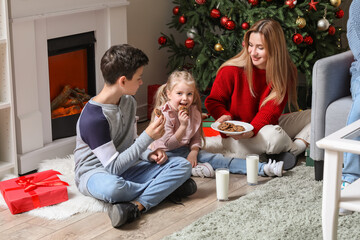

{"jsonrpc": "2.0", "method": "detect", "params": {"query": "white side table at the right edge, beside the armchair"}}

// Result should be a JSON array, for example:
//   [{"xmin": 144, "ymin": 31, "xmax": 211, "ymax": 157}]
[{"xmin": 316, "ymin": 120, "xmax": 360, "ymax": 240}]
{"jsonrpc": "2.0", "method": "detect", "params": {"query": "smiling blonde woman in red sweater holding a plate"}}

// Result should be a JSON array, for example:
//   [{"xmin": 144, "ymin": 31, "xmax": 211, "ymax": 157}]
[{"xmin": 205, "ymin": 19, "xmax": 311, "ymax": 170}]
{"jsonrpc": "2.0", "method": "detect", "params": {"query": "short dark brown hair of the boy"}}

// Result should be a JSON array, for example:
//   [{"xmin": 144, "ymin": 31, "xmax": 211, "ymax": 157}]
[{"xmin": 100, "ymin": 44, "xmax": 149, "ymax": 85}]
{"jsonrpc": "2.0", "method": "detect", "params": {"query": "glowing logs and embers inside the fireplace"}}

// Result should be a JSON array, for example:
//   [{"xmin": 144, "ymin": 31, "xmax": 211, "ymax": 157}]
[{"xmin": 51, "ymin": 85, "xmax": 91, "ymax": 119}]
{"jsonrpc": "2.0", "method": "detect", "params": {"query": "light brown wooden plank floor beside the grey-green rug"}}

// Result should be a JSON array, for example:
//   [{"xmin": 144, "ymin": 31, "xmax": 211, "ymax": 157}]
[{"xmin": 0, "ymin": 123, "xmax": 300, "ymax": 240}]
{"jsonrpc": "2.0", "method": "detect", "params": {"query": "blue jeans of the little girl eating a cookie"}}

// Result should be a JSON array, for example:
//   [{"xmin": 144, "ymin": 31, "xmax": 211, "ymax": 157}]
[{"xmin": 166, "ymin": 147, "xmax": 265, "ymax": 176}]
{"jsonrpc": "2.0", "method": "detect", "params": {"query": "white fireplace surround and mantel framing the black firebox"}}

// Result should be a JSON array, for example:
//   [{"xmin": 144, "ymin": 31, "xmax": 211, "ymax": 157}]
[{"xmin": 10, "ymin": 0, "xmax": 129, "ymax": 174}]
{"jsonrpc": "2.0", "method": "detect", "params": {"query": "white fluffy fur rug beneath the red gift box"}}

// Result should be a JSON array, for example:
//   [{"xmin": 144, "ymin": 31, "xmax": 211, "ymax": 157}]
[{"xmin": 0, "ymin": 136, "xmax": 225, "ymax": 220}]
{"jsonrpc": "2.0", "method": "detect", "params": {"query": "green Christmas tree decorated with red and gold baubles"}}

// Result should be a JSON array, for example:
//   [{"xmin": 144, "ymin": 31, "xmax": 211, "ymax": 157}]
[{"xmin": 158, "ymin": 0, "xmax": 344, "ymax": 97}]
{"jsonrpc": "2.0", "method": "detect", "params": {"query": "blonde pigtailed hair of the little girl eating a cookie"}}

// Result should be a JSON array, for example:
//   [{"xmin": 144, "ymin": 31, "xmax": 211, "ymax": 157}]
[{"xmin": 151, "ymin": 71, "xmax": 205, "ymax": 143}]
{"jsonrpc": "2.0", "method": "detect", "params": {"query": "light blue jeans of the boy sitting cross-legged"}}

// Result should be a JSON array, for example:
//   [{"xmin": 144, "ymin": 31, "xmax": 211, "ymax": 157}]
[{"xmin": 87, "ymin": 159, "xmax": 191, "ymax": 211}]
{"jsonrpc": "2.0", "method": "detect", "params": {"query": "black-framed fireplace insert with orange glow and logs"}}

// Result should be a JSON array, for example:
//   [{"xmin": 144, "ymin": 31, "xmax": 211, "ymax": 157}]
[{"xmin": 47, "ymin": 31, "xmax": 96, "ymax": 140}]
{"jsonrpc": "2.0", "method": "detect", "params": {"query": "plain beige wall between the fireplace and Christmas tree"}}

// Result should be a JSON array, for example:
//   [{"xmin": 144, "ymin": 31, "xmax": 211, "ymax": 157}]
[{"xmin": 127, "ymin": 0, "xmax": 186, "ymax": 120}]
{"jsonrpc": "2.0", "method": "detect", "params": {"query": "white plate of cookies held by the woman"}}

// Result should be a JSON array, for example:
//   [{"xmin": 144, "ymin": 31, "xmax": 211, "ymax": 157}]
[{"xmin": 211, "ymin": 121, "xmax": 254, "ymax": 135}]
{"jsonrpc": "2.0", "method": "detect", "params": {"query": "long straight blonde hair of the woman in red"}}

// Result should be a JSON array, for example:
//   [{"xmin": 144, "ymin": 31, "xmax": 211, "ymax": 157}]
[{"xmin": 218, "ymin": 19, "xmax": 299, "ymax": 109}]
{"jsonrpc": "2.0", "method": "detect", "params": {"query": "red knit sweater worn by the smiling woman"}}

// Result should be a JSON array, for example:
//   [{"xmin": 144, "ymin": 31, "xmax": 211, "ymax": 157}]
[{"xmin": 205, "ymin": 66, "xmax": 287, "ymax": 135}]
